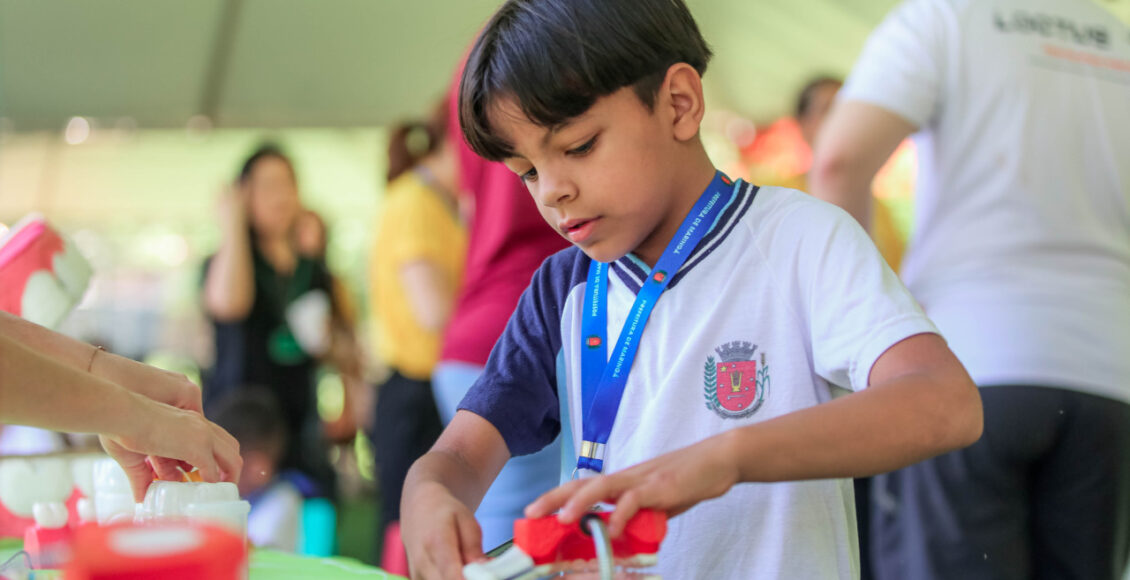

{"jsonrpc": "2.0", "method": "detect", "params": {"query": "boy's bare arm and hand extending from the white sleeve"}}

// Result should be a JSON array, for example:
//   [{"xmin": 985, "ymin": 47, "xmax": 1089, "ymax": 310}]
[{"xmin": 525, "ymin": 334, "xmax": 982, "ymax": 535}]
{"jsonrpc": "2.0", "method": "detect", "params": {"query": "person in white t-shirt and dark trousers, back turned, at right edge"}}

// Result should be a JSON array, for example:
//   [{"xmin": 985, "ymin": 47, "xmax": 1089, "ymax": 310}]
[{"xmin": 811, "ymin": 0, "xmax": 1130, "ymax": 579}]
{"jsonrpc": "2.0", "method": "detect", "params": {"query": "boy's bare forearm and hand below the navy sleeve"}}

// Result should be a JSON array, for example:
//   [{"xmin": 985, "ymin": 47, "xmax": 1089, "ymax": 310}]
[{"xmin": 400, "ymin": 410, "xmax": 510, "ymax": 578}]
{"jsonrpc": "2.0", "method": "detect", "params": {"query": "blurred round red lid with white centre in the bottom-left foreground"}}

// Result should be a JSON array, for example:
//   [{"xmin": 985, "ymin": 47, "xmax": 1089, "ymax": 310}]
[{"xmin": 63, "ymin": 522, "xmax": 247, "ymax": 580}]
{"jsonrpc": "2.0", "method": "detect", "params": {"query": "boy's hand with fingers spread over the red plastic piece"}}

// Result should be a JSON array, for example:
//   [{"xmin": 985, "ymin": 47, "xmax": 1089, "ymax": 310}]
[{"xmin": 525, "ymin": 433, "xmax": 738, "ymax": 538}]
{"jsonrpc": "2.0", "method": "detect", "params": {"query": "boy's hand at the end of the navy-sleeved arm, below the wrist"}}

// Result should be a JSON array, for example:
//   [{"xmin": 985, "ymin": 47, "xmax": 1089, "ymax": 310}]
[{"xmin": 400, "ymin": 482, "xmax": 486, "ymax": 580}]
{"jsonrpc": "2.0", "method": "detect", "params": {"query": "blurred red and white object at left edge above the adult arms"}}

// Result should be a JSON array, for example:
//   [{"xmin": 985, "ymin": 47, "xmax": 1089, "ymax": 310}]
[{"xmin": 0, "ymin": 214, "xmax": 92, "ymax": 328}]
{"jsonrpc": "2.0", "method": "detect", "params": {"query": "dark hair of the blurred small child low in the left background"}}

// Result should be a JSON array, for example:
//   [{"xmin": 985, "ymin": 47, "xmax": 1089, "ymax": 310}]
[{"xmin": 209, "ymin": 387, "xmax": 287, "ymax": 461}]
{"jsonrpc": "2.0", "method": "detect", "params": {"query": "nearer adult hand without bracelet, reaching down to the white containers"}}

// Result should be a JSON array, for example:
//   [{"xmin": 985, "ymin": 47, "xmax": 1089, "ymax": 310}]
[{"xmin": 99, "ymin": 395, "xmax": 243, "ymax": 501}]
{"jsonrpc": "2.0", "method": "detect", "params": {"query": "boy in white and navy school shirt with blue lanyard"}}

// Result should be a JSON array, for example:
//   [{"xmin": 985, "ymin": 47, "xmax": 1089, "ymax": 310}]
[{"xmin": 401, "ymin": 0, "xmax": 981, "ymax": 580}]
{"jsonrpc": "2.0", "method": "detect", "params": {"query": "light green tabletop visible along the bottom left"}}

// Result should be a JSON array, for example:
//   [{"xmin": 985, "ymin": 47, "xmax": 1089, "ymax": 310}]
[{"xmin": 0, "ymin": 539, "xmax": 402, "ymax": 580}]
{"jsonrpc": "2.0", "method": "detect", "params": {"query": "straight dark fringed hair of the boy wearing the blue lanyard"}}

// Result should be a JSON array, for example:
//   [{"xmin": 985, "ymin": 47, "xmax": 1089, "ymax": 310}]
[{"xmin": 459, "ymin": 0, "xmax": 711, "ymax": 161}]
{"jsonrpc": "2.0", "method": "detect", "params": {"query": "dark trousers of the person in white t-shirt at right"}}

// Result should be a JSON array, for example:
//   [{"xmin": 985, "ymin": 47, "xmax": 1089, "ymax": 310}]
[{"xmin": 871, "ymin": 387, "xmax": 1130, "ymax": 580}]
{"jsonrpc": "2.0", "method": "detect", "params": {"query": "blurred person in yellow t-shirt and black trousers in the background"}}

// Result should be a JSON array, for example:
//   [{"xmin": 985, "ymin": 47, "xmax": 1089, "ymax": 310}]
[{"xmin": 370, "ymin": 102, "xmax": 467, "ymax": 575}]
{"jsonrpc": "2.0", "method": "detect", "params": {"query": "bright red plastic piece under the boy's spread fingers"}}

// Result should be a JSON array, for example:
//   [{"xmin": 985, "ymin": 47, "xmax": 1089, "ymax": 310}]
[{"xmin": 514, "ymin": 510, "xmax": 667, "ymax": 565}]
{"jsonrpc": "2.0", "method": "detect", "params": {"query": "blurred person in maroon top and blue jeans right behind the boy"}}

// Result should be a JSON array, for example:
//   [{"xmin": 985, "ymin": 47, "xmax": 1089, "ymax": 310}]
[{"xmin": 432, "ymin": 67, "xmax": 576, "ymax": 549}]
